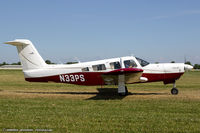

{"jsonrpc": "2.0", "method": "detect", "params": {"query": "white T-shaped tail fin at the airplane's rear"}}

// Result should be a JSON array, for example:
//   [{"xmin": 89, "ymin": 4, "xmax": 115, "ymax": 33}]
[{"xmin": 5, "ymin": 39, "xmax": 47, "ymax": 70}]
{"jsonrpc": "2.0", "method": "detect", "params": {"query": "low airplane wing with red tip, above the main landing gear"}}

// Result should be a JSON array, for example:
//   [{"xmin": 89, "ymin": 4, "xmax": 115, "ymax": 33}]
[{"xmin": 102, "ymin": 68, "xmax": 143, "ymax": 84}]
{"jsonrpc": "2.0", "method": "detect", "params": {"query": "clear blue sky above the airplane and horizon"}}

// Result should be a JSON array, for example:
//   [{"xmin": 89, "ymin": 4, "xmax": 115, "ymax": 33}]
[{"xmin": 0, "ymin": 0, "xmax": 200, "ymax": 64}]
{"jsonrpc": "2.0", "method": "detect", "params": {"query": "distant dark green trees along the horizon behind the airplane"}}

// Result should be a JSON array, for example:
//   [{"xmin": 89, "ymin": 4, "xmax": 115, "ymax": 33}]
[{"xmin": 0, "ymin": 60, "xmax": 200, "ymax": 69}]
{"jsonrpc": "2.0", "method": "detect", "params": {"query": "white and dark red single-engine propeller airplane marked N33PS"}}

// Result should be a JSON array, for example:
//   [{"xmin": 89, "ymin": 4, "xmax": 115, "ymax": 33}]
[{"xmin": 5, "ymin": 39, "xmax": 193, "ymax": 95}]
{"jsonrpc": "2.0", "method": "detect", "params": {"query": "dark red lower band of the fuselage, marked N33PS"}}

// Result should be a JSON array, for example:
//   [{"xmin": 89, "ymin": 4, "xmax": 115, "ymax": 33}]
[{"xmin": 25, "ymin": 72, "xmax": 183, "ymax": 85}]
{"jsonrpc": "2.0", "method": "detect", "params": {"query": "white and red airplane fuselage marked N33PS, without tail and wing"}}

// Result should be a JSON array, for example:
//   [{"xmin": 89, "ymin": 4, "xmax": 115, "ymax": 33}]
[{"xmin": 24, "ymin": 56, "xmax": 185, "ymax": 85}]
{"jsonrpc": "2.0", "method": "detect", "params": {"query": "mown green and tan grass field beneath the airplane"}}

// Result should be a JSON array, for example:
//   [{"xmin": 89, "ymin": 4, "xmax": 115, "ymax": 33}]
[{"xmin": 0, "ymin": 70, "xmax": 200, "ymax": 133}]
